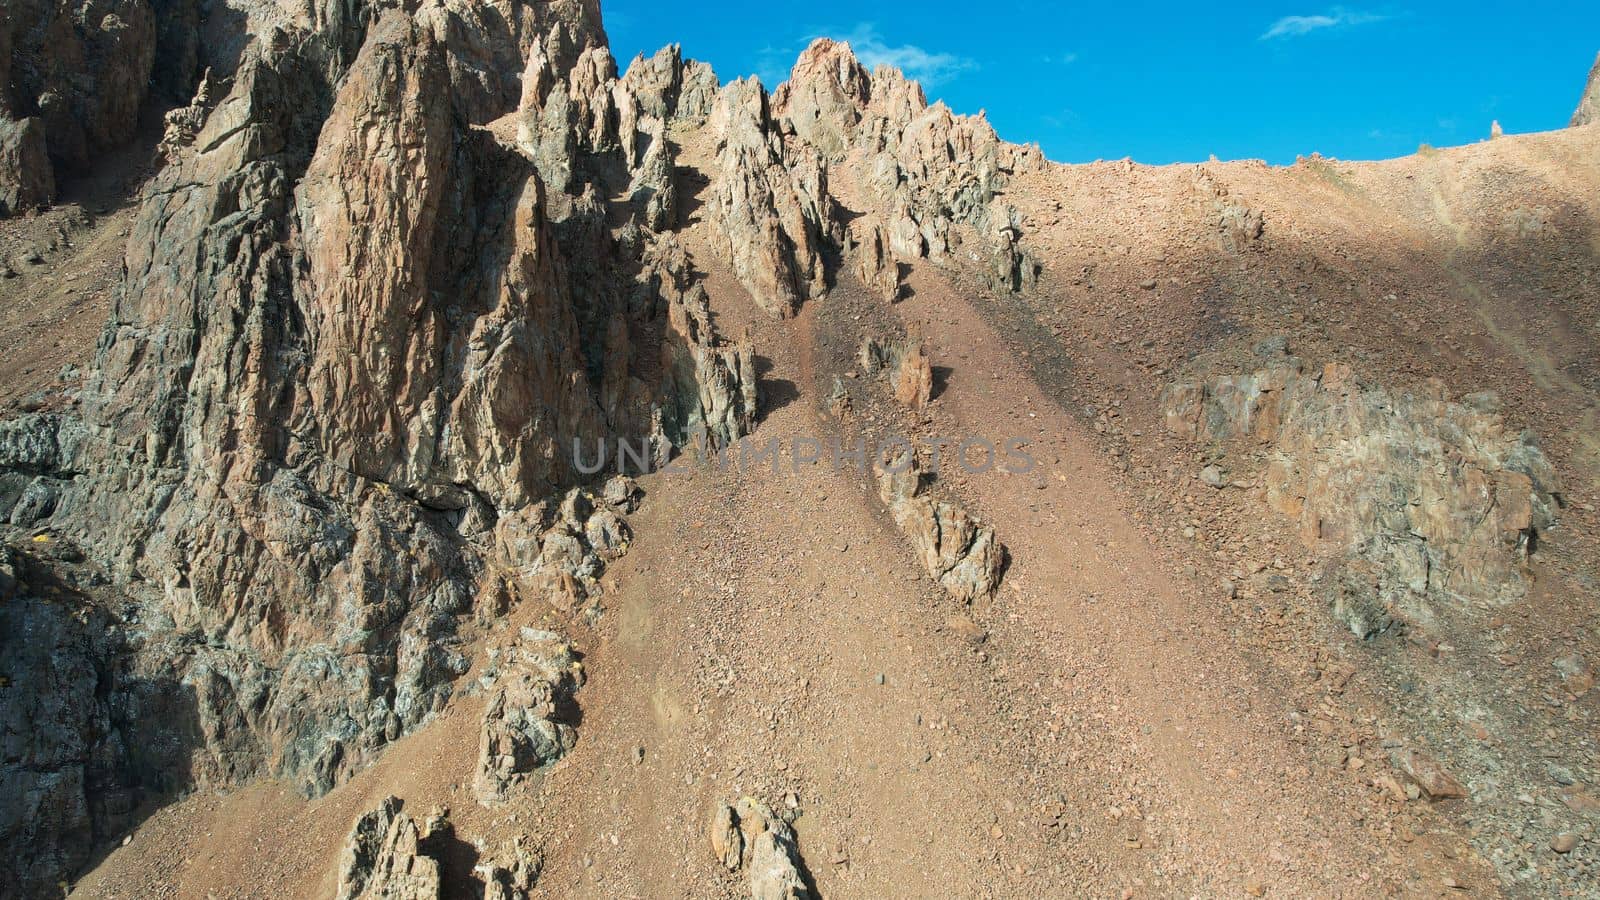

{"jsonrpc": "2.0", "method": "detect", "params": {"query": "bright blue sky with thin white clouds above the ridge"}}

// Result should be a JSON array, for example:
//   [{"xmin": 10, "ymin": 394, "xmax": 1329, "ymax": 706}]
[{"xmin": 602, "ymin": 0, "xmax": 1600, "ymax": 163}]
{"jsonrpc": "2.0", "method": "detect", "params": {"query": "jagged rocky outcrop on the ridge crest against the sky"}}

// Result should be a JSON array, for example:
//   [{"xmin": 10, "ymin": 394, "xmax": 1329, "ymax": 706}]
[{"xmin": 710, "ymin": 38, "xmax": 1045, "ymax": 315}]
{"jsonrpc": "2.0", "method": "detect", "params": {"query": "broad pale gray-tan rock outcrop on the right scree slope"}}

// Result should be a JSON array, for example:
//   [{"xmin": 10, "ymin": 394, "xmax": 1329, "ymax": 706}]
[{"xmin": 1163, "ymin": 344, "xmax": 1560, "ymax": 637}]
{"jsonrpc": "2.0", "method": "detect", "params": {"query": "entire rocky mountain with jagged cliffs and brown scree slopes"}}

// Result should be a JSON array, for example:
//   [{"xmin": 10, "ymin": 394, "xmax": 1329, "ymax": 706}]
[{"xmin": 0, "ymin": 7, "xmax": 1600, "ymax": 898}]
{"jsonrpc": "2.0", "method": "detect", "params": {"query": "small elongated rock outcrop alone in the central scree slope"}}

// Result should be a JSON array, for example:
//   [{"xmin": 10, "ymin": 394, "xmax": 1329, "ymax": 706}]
[{"xmin": 878, "ymin": 453, "xmax": 1006, "ymax": 602}]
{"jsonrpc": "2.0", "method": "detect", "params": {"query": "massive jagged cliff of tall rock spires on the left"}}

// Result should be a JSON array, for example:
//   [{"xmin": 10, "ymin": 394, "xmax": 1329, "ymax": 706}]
[{"xmin": 0, "ymin": 0, "xmax": 755, "ymax": 884}]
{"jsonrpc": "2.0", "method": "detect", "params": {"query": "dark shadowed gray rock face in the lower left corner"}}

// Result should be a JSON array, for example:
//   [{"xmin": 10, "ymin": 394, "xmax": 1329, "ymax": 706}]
[{"xmin": 0, "ymin": 540, "xmax": 197, "ymax": 897}]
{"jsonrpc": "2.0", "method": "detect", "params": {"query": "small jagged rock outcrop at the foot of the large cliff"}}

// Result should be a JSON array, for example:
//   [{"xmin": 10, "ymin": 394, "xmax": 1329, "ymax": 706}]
[{"xmin": 475, "ymin": 628, "xmax": 582, "ymax": 806}]
